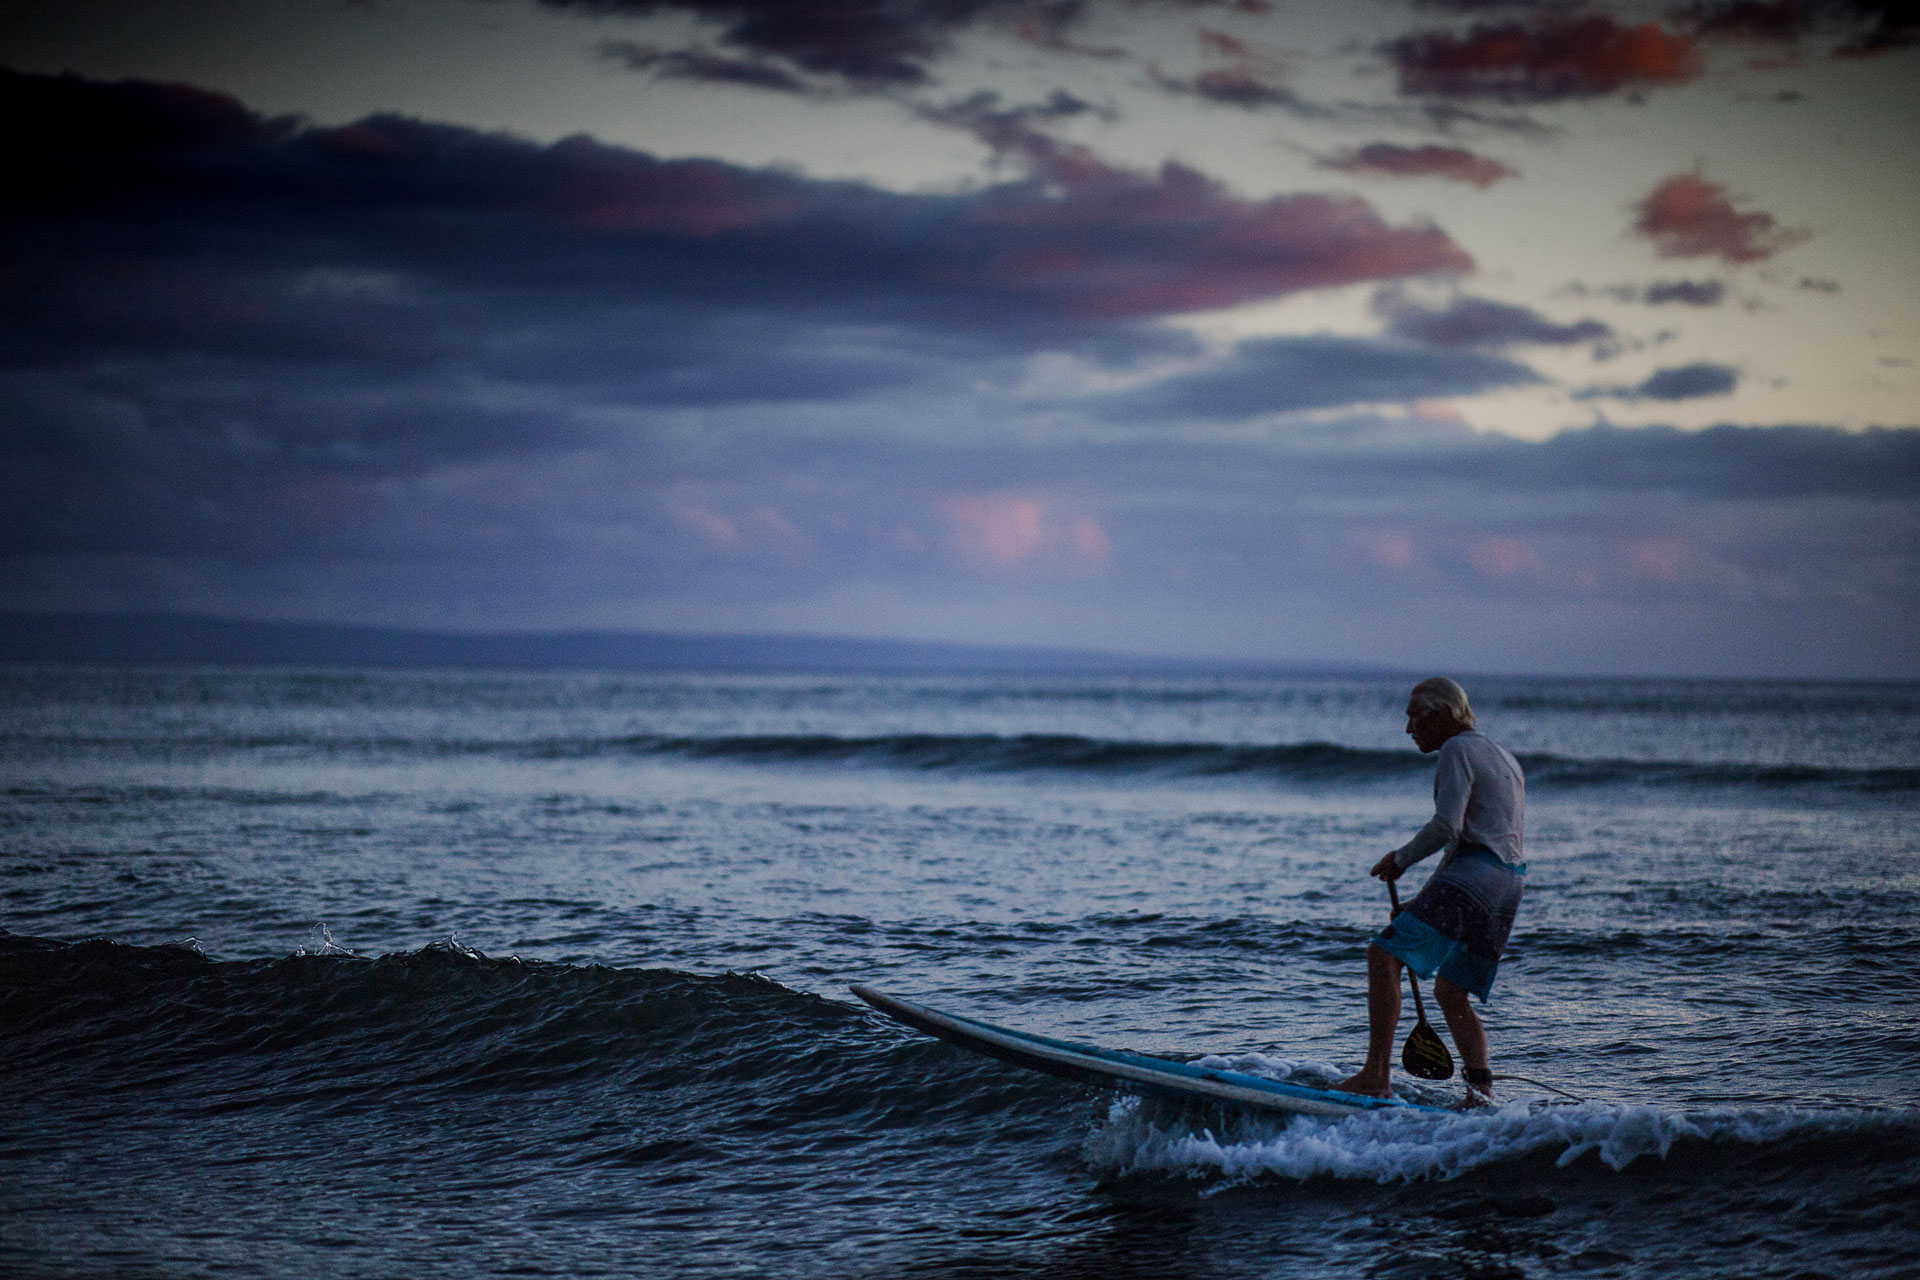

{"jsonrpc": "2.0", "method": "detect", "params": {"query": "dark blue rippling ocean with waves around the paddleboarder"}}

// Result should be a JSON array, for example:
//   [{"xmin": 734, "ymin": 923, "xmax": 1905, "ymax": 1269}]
[{"xmin": 0, "ymin": 666, "xmax": 1920, "ymax": 1280}]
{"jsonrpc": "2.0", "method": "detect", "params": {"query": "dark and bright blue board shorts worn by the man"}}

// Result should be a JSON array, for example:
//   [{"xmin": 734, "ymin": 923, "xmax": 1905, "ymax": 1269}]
[{"xmin": 1373, "ymin": 844, "xmax": 1526, "ymax": 1002}]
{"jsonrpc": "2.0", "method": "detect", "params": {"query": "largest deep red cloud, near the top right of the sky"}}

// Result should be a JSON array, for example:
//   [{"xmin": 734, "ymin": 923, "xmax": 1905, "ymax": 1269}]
[{"xmin": 1386, "ymin": 15, "xmax": 1701, "ymax": 102}]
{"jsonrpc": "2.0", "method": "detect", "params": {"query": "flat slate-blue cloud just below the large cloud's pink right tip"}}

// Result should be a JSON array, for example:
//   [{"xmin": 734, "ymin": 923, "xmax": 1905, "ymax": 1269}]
[{"xmin": 1106, "ymin": 336, "xmax": 1540, "ymax": 420}]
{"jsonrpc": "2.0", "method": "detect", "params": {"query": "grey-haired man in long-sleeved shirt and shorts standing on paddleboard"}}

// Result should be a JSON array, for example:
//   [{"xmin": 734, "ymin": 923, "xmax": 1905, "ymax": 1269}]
[{"xmin": 1336, "ymin": 676, "xmax": 1526, "ymax": 1098}]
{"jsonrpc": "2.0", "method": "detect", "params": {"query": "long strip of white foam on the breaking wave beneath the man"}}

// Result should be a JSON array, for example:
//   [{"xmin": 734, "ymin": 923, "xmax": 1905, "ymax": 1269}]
[{"xmin": 1083, "ymin": 1090, "xmax": 1870, "ymax": 1186}]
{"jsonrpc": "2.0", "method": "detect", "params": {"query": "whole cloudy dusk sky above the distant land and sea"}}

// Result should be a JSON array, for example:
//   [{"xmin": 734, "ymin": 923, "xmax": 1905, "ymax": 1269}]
[{"xmin": 0, "ymin": 0, "xmax": 1920, "ymax": 679}]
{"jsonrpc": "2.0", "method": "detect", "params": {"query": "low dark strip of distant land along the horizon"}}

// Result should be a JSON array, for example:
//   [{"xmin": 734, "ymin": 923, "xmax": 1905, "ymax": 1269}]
[{"xmin": 0, "ymin": 612, "xmax": 1392, "ymax": 676}]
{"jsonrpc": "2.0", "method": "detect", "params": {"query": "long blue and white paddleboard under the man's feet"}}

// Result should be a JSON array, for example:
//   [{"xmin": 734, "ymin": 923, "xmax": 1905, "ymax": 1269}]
[{"xmin": 852, "ymin": 984, "xmax": 1444, "ymax": 1117}]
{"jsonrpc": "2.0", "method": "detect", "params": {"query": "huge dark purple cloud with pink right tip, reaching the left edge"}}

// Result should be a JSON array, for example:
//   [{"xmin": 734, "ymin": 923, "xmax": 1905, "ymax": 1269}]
[{"xmin": 18, "ymin": 71, "xmax": 1473, "ymax": 345}]
